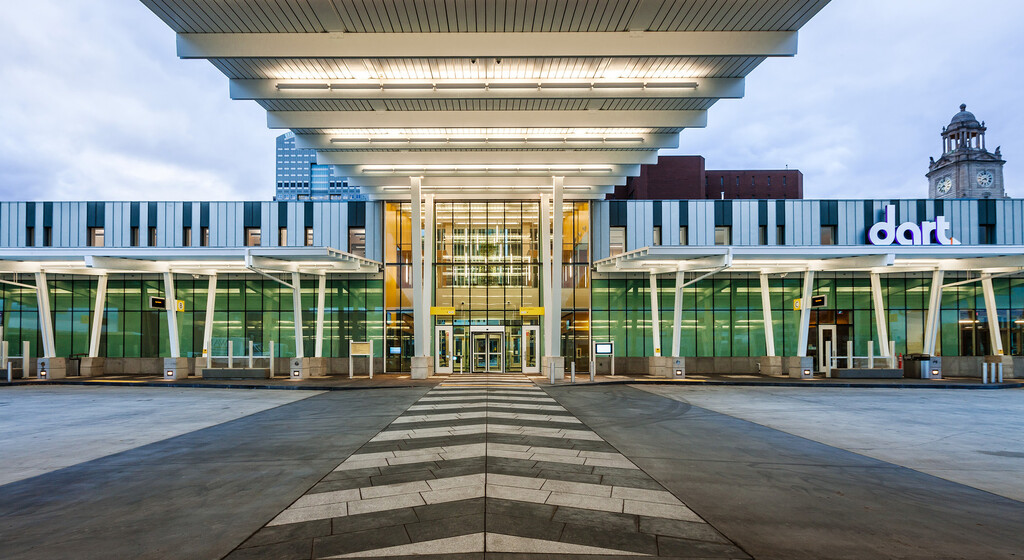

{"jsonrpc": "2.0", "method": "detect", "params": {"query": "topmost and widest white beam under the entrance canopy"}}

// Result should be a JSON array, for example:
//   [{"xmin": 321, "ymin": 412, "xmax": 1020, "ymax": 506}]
[{"xmin": 177, "ymin": 31, "xmax": 797, "ymax": 58}]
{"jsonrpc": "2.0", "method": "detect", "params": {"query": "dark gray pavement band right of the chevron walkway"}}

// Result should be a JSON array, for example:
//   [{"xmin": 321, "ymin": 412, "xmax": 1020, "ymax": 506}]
[{"xmin": 546, "ymin": 386, "xmax": 1024, "ymax": 560}]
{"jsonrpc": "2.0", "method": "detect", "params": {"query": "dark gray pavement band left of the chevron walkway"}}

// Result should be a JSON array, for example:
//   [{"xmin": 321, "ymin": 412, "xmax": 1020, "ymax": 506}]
[{"xmin": 0, "ymin": 388, "xmax": 425, "ymax": 559}]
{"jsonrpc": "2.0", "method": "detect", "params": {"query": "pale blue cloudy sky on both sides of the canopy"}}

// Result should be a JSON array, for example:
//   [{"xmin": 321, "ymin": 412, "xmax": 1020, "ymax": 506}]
[{"xmin": 0, "ymin": 0, "xmax": 1024, "ymax": 200}]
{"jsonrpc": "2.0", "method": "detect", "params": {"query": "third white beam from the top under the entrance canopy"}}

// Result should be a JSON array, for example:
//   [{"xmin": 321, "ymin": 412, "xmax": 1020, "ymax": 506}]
[{"xmin": 266, "ymin": 111, "xmax": 708, "ymax": 129}]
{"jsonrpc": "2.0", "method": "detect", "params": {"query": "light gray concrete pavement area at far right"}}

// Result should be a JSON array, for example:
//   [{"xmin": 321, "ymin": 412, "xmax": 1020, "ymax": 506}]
[{"xmin": 642, "ymin": 386, "xmax": 1024, "ymax": 502}]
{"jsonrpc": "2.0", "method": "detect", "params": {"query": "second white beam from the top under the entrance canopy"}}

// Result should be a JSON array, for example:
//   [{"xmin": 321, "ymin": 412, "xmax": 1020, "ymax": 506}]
[{"xmin": 228, "ymin": 78, "xmax": 744, "ymax": 100}]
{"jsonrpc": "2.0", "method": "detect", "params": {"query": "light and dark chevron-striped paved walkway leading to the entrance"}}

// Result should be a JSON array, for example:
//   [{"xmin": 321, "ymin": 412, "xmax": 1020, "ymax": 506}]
[{"xmin": 227, "ymin": 375, "xmax": 749, "ymax": 560}]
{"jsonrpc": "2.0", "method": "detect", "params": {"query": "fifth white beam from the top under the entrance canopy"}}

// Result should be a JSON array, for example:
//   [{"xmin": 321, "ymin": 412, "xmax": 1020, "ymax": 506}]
[{"xmin": 316, "ymin": 150, "xmax": 657, "ymax": 165}]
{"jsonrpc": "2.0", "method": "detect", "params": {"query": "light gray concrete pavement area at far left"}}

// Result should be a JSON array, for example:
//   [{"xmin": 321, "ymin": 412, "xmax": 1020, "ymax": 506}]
[{"xmin": 0, "ymin": 385, "xmax": 319, "ymax": 485}]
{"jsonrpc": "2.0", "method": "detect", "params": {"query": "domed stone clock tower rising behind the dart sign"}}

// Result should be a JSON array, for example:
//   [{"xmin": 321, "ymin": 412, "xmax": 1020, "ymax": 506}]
[{"xmin": 926, "ymin": 104, "xmax": 1007, "ymax": 199}]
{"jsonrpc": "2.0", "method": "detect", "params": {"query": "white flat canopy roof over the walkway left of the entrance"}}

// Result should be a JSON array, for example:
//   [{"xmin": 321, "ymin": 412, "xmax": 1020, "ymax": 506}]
[{"xmin": 0, "ymin": 247, "xmax": 381, "ymax": 275}]
